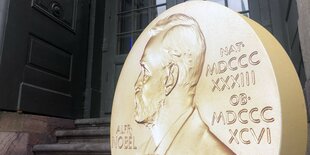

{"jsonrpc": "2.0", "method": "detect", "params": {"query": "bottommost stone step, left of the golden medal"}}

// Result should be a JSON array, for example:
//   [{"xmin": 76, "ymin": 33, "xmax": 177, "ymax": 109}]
[{"xmin": 32, "ymin": 142, "xmax": 111, "ymax": 153}]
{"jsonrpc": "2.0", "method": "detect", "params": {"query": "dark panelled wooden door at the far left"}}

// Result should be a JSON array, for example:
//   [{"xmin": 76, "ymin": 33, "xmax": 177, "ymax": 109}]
[{"xmin": 0, "ymin": 0, "xmax": 90, "ymax": 118}]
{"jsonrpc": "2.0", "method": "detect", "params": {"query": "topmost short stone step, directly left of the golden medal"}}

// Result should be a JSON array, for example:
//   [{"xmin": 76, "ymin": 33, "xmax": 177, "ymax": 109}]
[{"xmin": 74, "ymin": 116, "xmax": 111, "ymax": 128}]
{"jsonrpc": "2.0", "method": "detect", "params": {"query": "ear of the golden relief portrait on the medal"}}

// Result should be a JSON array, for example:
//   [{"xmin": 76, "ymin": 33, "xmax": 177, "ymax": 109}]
[{"xmin": 165, "ymin": 64, "xmax": 179, "ymax": 96}]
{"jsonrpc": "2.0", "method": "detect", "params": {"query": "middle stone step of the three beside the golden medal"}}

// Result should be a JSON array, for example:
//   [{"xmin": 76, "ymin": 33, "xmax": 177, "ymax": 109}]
[{"xmin": 55, "ymin": 127, "xmax": 110, "ymax": 143}]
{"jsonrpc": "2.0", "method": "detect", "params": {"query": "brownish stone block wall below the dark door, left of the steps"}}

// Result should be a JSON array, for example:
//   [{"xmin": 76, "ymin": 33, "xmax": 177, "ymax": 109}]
[{"xmin": 0, "ymin": 112, "xmax": 74, "ymax": 155}]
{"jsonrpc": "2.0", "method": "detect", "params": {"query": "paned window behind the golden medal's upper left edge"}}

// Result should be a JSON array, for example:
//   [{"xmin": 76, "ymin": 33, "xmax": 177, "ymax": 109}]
[{"xmin": 116, "ymin": 0, "xmax": 166, "ymax": 54}]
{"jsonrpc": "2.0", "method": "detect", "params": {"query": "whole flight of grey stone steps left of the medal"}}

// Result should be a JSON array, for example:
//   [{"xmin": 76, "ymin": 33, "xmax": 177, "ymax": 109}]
[{"xmin": 33, "ymin": 117, "xmax": 111, "ymax": 155}]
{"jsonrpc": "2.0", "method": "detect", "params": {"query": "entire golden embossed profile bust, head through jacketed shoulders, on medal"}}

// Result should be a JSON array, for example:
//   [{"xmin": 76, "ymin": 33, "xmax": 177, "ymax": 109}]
[{"xmin": 135, "ymin": 14, "xmax": 234, "ymax": 155}]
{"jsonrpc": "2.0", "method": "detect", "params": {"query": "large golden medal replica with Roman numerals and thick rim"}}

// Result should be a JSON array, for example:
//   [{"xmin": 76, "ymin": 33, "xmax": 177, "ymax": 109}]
[{"xmin": 110, "ymin": 1, "xmax": 307, "ymax": 155}]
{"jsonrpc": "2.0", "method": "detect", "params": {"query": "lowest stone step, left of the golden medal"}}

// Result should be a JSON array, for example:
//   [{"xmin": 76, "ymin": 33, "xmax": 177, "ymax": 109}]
[{"xmin": 33, "ymin": 143, "xmax": 111, "ymax": 155}]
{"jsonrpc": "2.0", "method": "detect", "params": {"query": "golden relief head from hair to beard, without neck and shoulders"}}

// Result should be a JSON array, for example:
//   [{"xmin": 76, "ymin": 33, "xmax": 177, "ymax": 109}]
[{"xmin": 135, "ymin": 14, "xmax": 205, "ymax": 125}]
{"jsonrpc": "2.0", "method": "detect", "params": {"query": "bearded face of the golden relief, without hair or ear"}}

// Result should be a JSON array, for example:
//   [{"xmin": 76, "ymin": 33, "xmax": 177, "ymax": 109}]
[{"xmin": 135, "ymin": 43, "xmax": 166, "ymax": 124}]
